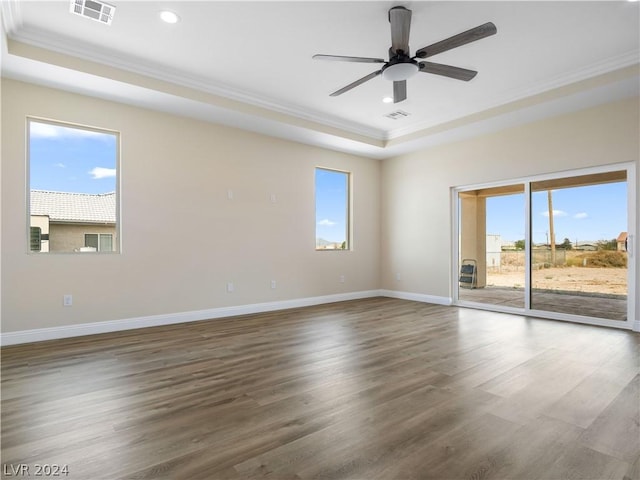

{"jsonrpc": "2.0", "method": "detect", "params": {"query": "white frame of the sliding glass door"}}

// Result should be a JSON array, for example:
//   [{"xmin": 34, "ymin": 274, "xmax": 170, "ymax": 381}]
[{"xmin": 450, "ymin": 162, "xmax": 640, "ymax": 330}]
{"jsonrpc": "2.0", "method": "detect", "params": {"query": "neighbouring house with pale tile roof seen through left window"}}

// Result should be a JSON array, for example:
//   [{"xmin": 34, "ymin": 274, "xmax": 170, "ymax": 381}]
[{"xmin": 30, "ymin": 190, "xmax": 117, "ymax": 252}]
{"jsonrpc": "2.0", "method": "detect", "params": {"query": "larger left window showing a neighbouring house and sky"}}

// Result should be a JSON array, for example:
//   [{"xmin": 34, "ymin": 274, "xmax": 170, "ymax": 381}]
[{"xmin": 27, "ymin": 119, "xmax": 119, "ymax": 253}]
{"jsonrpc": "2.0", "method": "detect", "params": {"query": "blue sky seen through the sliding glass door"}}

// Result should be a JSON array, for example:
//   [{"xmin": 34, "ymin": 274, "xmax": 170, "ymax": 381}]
[{"xmin": 487, "ymin": 182, "xmax": 627, "ymax": 243}]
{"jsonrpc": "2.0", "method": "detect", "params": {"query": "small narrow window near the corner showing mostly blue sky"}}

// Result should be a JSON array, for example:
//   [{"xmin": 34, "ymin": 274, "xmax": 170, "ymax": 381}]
[{"xmin": 315, "ymin": 168, "xmax": 350, "ymax": 250}]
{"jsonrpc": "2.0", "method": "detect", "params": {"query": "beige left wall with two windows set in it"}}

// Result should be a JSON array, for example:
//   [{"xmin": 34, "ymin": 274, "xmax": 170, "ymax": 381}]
[{"xmin": 1, "ymin": 79, "xmax": 380, "ymax": 332}]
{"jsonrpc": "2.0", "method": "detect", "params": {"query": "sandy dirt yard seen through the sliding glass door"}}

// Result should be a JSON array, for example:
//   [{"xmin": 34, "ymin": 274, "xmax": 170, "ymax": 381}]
[{"xmin": 487, "ymin": 267, "xmax": 627, "ymax": 295}]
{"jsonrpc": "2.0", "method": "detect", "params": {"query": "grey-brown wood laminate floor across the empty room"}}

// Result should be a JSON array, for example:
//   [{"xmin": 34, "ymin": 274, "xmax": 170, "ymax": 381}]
[{"xmin": 1, "ymin": 298, "xmax": 640, "ymax": 480}]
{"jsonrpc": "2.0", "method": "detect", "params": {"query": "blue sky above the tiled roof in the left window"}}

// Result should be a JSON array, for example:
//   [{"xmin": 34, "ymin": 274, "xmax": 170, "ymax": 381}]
[{"xmin": 29, "ymin": 121, "xmax": 117, "ymax": 193}]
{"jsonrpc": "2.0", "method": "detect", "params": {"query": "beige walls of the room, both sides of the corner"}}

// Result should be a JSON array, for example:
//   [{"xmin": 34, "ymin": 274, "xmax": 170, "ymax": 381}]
[{"xmin": 1, "ymin": 79, "xmax": 640, "ymax": 332}]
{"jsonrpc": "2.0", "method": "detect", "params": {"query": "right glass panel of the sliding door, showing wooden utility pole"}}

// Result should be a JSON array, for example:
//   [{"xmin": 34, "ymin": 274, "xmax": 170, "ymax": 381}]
[{"xmin": 531, "ymin": 171, "xmax": 628, "ymax": 320}]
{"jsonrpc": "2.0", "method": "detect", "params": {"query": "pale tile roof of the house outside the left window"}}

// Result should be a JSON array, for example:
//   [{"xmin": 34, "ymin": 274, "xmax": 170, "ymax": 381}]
[{"xmin": 31, "ymin": 190, "xmax": 116, "ymax": 223}]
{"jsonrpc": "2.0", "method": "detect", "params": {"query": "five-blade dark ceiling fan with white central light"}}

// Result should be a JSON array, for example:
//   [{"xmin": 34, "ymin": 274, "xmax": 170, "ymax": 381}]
[{"xmin": 313, "ymin": 7, "xmax": 498, "ymax": 103}]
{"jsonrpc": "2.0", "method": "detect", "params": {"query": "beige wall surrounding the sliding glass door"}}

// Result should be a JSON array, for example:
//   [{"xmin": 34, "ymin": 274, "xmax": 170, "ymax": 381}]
[{"xmin": 381, "ymin": 97, "xmax": 640, "ymax": 312}]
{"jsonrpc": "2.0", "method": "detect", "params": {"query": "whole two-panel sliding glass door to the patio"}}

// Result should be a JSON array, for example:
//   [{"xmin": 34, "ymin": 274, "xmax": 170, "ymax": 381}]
[{"xmin": 454, "ymin": 165, "xmax": 635, "ymax": 324}]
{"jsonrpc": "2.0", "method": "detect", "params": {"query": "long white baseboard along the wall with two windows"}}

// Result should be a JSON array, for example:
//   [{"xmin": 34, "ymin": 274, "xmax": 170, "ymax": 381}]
[{"xmin": 0, "ymin": 290, "xmax": 383, "ymax": 346}]
